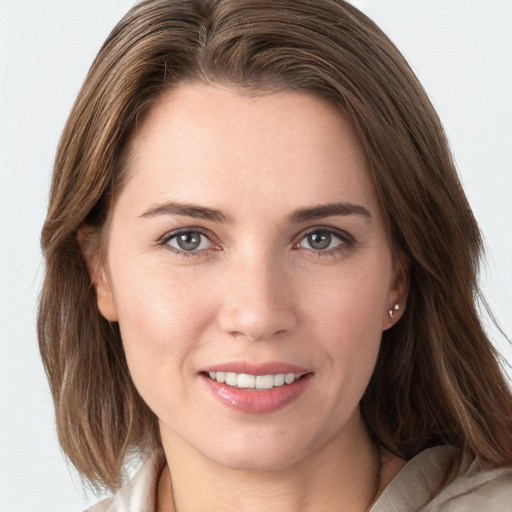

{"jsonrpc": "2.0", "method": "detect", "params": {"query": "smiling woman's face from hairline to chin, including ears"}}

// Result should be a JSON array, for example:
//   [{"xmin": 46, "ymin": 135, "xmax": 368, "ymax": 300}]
[{"xmin": 95, "ymin": 85, "xmax": 405, "ymax": 469}]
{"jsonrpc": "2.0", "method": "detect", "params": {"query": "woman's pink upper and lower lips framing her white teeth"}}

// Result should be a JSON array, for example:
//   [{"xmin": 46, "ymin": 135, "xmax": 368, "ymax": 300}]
[{"xmin": 199, "ymin": 362, "xmax": 313, "ymax": 414}]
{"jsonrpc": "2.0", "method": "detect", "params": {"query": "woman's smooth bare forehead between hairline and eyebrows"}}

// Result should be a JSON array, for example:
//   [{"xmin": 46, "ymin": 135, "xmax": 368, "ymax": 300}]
[{"xmin": 119, "ymin": 84, "xmax": 375, "ymax": 218}]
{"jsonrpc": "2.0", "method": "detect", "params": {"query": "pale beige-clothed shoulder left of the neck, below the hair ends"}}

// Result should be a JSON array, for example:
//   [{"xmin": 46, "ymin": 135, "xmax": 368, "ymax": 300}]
[{"xmin": 85, "ymin": 450, "xmax": 165, "ymax": 512}]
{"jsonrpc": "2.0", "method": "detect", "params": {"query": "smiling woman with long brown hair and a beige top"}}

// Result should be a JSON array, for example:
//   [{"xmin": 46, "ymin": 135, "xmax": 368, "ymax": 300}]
[{"xmin": 39, "ymin": 0, "xmax": 512, "ymax": 512}]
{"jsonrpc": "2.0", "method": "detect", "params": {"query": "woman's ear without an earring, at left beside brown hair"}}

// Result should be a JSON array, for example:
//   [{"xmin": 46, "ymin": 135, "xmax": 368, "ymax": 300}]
[{"xmin": 77, "ymin": 224, "xmax": 119, "ymax": 322}]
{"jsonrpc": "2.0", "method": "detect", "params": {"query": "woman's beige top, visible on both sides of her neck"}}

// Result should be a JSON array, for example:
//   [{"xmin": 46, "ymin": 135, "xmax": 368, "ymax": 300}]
[{"xmin": 86, "ymin": 446, "xmax": 512, "ymax": 512}]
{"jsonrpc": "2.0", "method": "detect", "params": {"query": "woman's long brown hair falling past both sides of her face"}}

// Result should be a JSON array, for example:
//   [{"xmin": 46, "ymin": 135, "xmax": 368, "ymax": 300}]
[{"xmin": 38, "ymin": 0, "xmax": 512, "ymax": 489}]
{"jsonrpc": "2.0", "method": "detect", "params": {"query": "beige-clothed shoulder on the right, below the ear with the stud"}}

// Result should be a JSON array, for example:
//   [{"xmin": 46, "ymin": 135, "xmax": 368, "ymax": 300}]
[{"xmin": 371, "ymin": 446, "xmax": 512, "ymax": 512}]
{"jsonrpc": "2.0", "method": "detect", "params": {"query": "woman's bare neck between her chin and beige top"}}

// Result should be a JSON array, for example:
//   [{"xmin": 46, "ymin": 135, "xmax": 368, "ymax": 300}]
[{"xmin": 158, "ymin": 412, "xmax": 394, "ymax": 512}]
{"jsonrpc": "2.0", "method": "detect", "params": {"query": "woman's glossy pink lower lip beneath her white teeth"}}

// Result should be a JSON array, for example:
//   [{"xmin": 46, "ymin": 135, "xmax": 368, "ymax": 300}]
[{"xmin": 201, "ymin": 373, "xmax": 312, "ymax": 414}]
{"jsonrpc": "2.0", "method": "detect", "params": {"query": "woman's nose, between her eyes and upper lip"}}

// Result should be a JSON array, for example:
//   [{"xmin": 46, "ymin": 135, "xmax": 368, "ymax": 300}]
[{"xmin": 219, "ymin": 250, "xmax": 298, "ymax": 341}]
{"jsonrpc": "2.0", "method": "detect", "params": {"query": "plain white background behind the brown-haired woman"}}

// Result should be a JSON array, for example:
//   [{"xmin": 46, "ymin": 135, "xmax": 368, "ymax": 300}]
[{"xmin": 0, "ymin": 0, "xmax": 512, "ymax": 512}]
